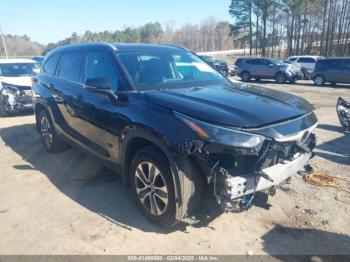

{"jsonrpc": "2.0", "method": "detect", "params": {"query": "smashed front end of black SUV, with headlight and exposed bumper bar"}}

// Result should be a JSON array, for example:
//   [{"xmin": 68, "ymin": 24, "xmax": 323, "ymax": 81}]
[{"xmin": 174, "ymin": 113, "xmax": 317, "ymax": 211}]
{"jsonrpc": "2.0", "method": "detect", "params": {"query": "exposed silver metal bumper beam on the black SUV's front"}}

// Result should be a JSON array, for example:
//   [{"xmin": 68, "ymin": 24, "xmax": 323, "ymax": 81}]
[{"xmin": 219, "ymin": 150, "xmax": 311, "ymax": 200}]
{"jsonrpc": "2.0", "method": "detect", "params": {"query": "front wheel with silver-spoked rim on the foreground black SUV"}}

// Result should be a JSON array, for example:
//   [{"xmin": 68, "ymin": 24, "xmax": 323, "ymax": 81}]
[{"xmin": 129, "ymin": 146, "xmax": 179, "ymax": 227}]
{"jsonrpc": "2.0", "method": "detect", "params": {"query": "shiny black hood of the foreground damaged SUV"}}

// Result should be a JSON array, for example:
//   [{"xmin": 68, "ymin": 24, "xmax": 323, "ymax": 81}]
[{"xmin": 146, "ymin": 83, "xmax": 314, "ymax": 128}]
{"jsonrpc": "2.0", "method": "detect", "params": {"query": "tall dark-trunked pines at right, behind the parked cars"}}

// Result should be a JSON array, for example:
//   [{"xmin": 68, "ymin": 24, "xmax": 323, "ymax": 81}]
[{"xmin": 229, "ymin": 0, "xmax": 350, "ymax": 57}]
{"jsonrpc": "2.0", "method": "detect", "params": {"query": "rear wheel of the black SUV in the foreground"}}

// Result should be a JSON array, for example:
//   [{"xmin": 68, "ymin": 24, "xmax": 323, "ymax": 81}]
[{"xmin": 38, "ymin": 110, "xmax": 69, "ymax": 153}]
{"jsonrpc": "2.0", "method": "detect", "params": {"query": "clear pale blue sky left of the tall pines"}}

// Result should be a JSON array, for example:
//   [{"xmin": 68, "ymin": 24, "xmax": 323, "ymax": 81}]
[{"xmin": 0, "ymin": 0, "xmax": 230, "ymax": 44}]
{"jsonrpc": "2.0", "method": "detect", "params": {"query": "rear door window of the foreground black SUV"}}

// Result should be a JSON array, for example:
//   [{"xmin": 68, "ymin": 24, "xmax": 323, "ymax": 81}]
[{"xmin": 58, "ymin": 52, "xmax": 84, "ymax": 82}]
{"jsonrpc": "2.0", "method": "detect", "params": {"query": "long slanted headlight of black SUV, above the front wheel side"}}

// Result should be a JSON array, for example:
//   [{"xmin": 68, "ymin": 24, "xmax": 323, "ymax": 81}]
[{"xmin": 174, "ymin": 112, "xmax": 265, "ymax": 150}]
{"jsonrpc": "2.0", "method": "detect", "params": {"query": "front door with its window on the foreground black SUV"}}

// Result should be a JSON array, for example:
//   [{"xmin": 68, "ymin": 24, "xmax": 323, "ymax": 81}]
[{"xmin": 74, "ymin": 51, "xmax": 126, "ymax": 162}]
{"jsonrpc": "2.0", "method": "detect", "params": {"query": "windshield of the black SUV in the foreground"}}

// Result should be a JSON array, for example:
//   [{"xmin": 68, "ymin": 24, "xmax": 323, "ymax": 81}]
[{"xmin": 119, "ymin": 50, "xmax": 226, "ymax": 90}]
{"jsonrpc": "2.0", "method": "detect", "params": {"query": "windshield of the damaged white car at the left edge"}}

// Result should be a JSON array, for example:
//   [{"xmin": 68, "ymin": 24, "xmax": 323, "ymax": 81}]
[{"xmin": 0, "ymin": 63, "xmax": 40, "ymax": 77}]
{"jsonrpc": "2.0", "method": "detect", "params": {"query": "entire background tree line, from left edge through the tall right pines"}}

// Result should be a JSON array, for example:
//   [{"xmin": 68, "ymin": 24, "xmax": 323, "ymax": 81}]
[{"xmin": 0, "ymin": 0, "xmax": 350, "ymax": 57}]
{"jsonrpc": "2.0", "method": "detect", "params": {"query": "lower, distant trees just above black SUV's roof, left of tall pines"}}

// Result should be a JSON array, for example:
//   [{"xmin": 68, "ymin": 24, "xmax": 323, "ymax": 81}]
[{"xmin": 43, "ymin": 18, "xmax": 233, "ymax": 54}]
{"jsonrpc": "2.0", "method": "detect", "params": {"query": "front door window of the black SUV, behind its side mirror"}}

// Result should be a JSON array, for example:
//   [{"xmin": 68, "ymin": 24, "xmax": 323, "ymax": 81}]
[{"xmin": 84, "ymin": 51, "xmax": 119, "ymax": 90}]
